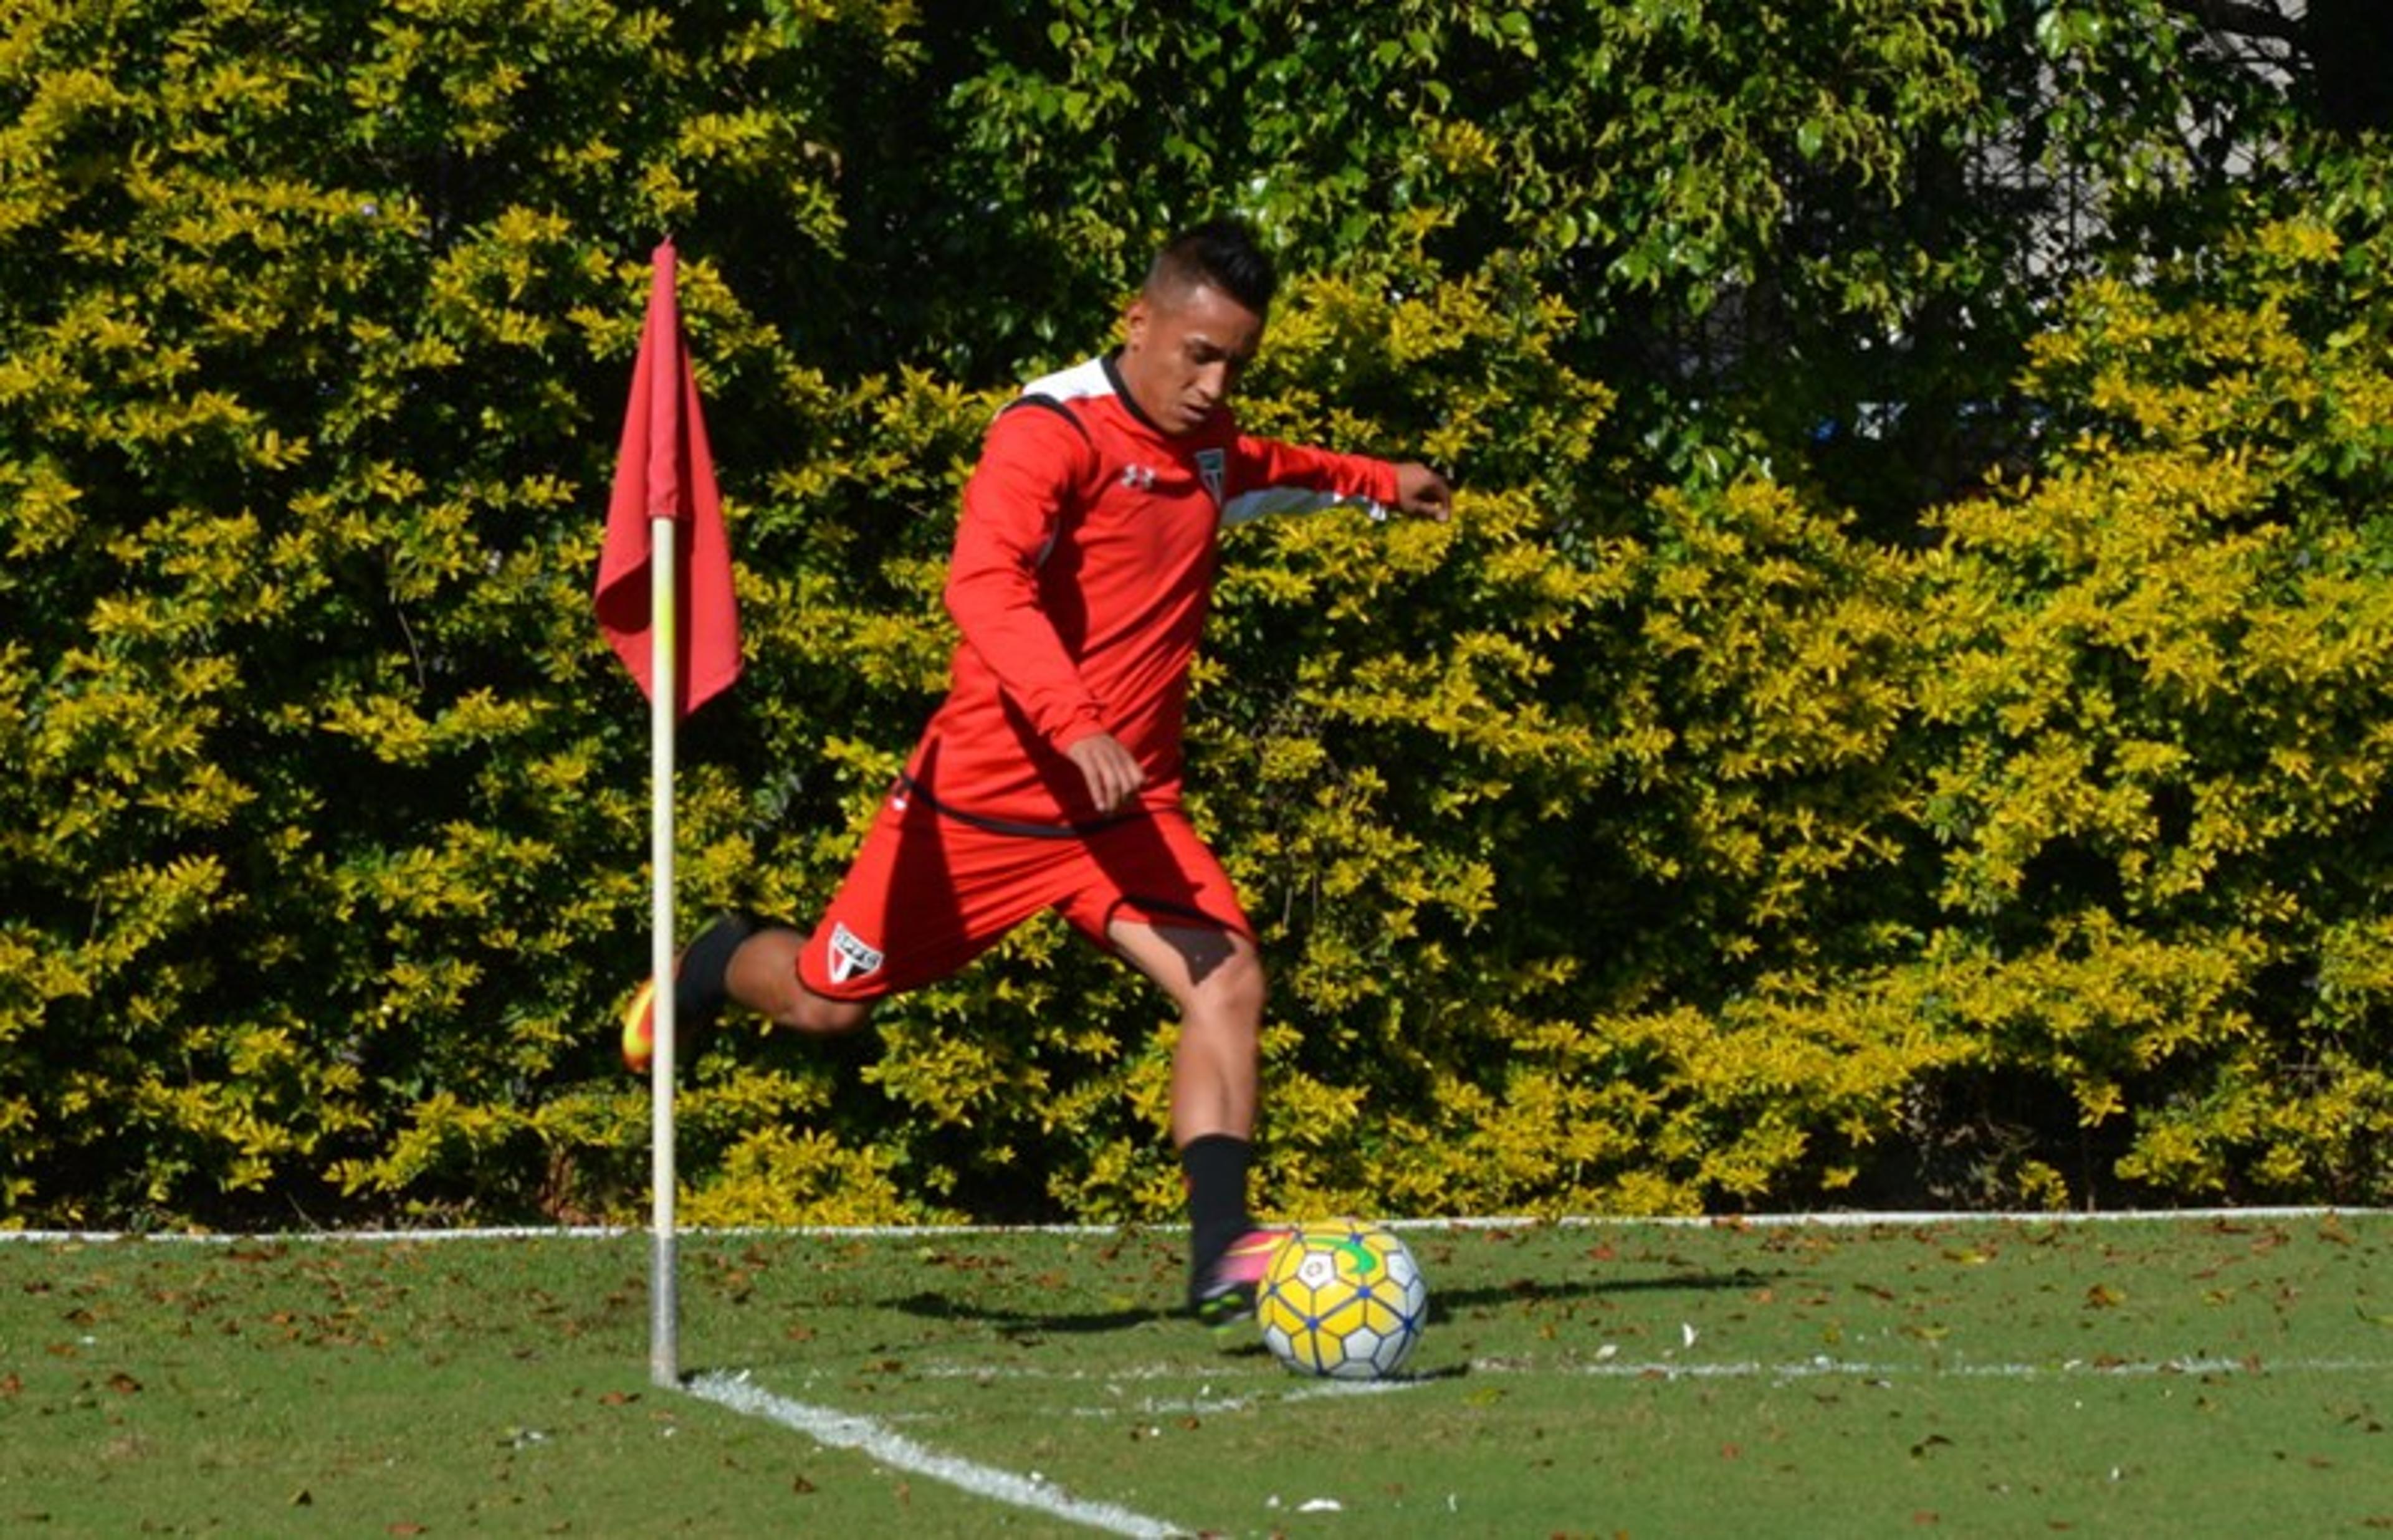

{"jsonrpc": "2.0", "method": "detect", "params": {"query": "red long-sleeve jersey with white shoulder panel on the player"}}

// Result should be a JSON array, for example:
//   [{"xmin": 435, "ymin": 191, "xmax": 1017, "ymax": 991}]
[{"xmin": 907, "ymin": 356, "xmax": 1398, "ymax": 830}]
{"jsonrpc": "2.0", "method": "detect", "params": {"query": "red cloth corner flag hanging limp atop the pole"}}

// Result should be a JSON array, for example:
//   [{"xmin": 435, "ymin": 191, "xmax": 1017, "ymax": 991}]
[{"xmin": 598, "ymin": 242, "xmax": 740, "ymax": 715}]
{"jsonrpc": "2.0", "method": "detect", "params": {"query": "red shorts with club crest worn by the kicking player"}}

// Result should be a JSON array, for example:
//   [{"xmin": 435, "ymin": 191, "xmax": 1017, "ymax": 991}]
[{"xmin": 797, "ymin": 789, "xmax": 1254, "ymax": 999}]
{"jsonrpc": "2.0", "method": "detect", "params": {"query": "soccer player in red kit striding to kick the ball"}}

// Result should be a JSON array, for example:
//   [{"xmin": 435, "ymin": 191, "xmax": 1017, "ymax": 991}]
[{"xmin": 622, "ymin": 220, "xmax": 1450, "ymax": 1325}]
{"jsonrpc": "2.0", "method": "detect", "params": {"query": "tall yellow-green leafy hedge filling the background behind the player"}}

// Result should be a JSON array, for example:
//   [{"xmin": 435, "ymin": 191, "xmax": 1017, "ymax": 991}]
[{"xmin": 0, "ymin": 0, "xmax": 2393, "ymax": 1224}]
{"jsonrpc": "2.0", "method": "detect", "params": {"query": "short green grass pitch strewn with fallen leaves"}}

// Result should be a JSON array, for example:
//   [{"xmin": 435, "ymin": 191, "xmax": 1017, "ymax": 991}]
[{"xmin": 0, "ymin": 1212, "xmax": 2393, "ymax": 1540}]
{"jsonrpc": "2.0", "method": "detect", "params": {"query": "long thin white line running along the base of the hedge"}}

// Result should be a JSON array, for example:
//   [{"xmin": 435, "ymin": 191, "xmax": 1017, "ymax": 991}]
[{"xmin": 0, "ymin": 1205, "xmax": 2393, "ymax": 1243}]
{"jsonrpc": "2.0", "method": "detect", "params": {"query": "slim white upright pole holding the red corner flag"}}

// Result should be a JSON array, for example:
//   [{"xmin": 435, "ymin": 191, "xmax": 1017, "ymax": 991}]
[{"xmin": 649, "ymin": 516, "xmax": 682, "ymax": 1387}]
